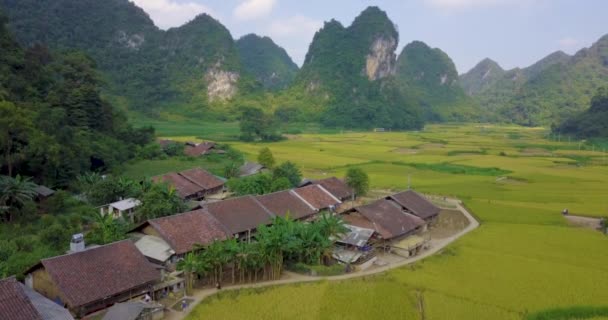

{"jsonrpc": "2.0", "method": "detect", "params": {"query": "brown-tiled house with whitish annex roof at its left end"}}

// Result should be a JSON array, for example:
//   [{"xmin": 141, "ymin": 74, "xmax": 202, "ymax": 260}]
[{"xmin": 132, "ymin": 209, "xmax": 231, "ymax": 269}]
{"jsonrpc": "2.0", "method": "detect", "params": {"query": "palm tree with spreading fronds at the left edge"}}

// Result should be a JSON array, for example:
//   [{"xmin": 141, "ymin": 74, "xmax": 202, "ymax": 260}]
[{"xmin": 0, "ymin": 175, "xmax": 37, "ymax": 221}]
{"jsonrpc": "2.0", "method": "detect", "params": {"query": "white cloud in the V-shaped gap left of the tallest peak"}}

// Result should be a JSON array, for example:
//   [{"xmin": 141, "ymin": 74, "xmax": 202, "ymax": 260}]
[{"xmin": 267, "ymin": 15, "xmax": 323, "ymax": 65}]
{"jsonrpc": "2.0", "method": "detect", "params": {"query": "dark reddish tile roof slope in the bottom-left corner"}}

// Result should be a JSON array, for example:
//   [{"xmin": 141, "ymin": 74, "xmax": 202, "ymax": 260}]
[{"xmin": 0, "ymin": 278, "xmax": 43, "ymax": 320}]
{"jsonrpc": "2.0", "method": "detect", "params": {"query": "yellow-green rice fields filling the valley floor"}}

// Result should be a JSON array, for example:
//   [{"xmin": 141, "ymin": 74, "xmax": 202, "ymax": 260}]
[{"xmin": 153, "ymin": 125, "xmax": 608, "ymax": 319}]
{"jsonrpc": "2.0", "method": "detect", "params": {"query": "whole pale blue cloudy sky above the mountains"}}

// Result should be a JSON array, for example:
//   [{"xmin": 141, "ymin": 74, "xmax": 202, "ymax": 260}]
[{"xmin": 131, "ymin": 0, "xmax": 608, "ymax": 73}]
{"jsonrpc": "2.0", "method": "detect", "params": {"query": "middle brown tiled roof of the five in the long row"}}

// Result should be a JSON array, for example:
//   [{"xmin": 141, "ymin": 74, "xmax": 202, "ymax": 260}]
[{"xmin": 257, "ymin": 190, "xmax": 316, "ymax": 219}]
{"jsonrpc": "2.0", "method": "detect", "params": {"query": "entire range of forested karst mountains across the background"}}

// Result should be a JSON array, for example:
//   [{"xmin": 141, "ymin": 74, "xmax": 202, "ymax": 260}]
[{"xmin": 0, "ymin": 0, "xmax": 608, "ymax": 129}]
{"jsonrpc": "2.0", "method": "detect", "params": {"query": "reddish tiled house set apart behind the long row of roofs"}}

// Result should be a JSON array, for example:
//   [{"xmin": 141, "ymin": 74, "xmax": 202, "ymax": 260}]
[{"xmin": 152, "ymin": 168, "xmax": 224, "ymax": 200}]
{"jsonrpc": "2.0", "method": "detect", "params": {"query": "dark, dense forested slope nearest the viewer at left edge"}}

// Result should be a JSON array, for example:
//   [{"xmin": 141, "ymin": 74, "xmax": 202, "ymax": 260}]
[{"xmin": 0, "ymin": 14, "xmax": 154, "ymax": 186}]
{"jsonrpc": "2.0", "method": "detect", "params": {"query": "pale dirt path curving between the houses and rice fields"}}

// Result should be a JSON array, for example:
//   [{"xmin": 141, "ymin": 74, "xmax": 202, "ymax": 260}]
[{"xmin": 165, "ymin": 199, "xmax": 479, "ymax": 320}]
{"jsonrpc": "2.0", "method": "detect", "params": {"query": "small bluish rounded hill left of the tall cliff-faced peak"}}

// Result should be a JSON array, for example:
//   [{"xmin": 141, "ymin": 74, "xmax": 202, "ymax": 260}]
[{"xmin": 236, "ymin": 34, "xmax": 298, "ymax": 90}]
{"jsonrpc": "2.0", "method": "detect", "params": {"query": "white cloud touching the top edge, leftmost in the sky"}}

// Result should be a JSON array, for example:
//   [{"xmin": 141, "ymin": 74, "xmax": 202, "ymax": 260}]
[{"xmin": 130, "ymin": 0, "xmax": 217, "ymax": 30}]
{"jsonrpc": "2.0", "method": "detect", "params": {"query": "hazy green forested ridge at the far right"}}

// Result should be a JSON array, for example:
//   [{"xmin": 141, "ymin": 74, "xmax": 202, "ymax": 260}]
[{"xmin": 460, "ymin": 35, "xmax": 608, "ymax": 125}]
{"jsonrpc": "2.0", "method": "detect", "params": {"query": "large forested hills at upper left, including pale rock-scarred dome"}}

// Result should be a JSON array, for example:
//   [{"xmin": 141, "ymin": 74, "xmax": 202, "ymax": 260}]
[{"xmin": 0, "ymin": 0, "xmax": 247, "ymax": 115}]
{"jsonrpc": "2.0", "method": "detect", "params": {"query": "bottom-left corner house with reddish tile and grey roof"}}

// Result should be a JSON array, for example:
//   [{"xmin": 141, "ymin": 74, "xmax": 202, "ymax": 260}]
[{"xmin": 0, "ymin": 278, "xmax": 74, "ymax": 320}]
